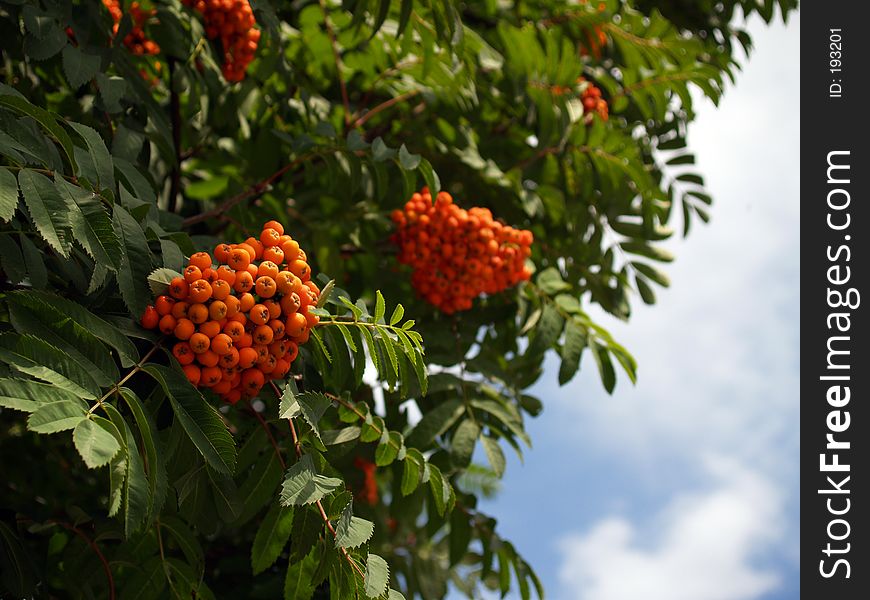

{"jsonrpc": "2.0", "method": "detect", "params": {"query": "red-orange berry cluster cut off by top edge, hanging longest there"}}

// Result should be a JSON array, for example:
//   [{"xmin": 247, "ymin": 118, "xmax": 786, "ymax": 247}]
[{"xmin": 182, "ymin": 0, "xmax": 260, "ymax": 81}]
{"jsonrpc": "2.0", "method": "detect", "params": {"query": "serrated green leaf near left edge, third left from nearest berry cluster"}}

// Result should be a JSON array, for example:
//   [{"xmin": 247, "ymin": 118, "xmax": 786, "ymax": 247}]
[{"xmin": 18, "ymin": 169, "xmax": 70, "ymax": 257}]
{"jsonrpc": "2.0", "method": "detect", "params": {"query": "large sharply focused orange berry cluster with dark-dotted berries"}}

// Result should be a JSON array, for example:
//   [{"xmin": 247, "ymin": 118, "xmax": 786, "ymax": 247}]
[{"xmin": 141, "ymin": 221, "xmax": 320, "ymax": 404}]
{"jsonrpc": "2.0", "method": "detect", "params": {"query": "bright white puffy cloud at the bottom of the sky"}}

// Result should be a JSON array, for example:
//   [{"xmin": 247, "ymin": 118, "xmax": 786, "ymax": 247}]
[{"xmin": 559, "ymin": 457, "xmax": 783, "ymax": 600}]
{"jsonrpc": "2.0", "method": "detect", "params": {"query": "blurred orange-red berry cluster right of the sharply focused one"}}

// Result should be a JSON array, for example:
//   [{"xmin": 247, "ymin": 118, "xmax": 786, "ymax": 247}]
[{"xmin": 391, "ymin": 188, "xmax": 533, "ymax": 314}]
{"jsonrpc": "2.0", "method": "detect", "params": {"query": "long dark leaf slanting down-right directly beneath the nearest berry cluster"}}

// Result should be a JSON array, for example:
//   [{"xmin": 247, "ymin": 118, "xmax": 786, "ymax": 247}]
[{"xmin": 142, "ymin": 365, "xmax": 236, "ymax": 475}]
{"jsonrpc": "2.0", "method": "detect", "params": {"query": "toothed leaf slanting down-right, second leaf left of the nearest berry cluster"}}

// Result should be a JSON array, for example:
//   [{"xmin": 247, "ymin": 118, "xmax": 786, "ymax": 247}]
[{"xmin": 55, "ymin": 179, "xmax": 123, "ymax": 271}]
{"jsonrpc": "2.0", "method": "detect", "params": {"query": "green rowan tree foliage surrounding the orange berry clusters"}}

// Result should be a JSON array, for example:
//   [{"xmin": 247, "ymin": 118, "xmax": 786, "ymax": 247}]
[{"xmin": 0, "ymin": 0, "xmax": 794, "ymax": 600}]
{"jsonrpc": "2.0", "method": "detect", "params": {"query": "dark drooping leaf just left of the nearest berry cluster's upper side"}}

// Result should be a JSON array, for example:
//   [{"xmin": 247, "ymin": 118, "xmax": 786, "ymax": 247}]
[{"xmin": 112, "ymin": 204, "xmax": 152, "ymax": 318}]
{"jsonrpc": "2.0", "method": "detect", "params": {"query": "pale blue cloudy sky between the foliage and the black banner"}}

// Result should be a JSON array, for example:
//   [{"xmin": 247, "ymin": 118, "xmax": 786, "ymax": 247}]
[{"xmin": 480, "ymin": 10, "xmax": 800, "ymax": 600}]
